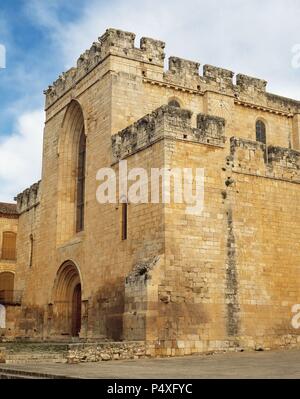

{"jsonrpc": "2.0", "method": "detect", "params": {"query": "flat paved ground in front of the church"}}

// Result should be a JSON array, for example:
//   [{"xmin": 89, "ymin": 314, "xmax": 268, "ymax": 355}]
[{"xmin": 1, "ymin": 350, "xmax": 300, "ymax": 379}]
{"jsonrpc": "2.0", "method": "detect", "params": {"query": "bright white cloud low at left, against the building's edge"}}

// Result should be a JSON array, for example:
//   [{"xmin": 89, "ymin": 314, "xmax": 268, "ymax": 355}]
[{"xmin": 0, "ymin": 110, "xmax": 44, "ymax": 202}]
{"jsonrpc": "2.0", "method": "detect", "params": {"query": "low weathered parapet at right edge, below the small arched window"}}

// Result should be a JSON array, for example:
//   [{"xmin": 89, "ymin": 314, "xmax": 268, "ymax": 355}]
[{"xmin": 230, "ymin": 137, "xmax": 300, "ymax": 183}]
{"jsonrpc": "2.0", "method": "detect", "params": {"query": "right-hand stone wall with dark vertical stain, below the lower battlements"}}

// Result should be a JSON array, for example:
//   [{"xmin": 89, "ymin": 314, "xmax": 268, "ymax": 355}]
[{"xmin": 149, "ymin": 134, "xmax": 300, "ymax": 355}]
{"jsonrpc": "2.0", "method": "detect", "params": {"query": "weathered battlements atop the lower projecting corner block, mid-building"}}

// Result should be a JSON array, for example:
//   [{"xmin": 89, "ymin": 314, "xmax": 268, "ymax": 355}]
[{"xmin": 112, "ymin": 105, "xmax": 225, "ymax": 163}]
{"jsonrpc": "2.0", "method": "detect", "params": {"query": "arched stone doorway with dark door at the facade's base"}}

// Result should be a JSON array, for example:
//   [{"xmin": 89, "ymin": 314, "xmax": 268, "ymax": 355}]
[{"xmin": 52, "ymin": 261, "xmax": 82, "ymax": 337}]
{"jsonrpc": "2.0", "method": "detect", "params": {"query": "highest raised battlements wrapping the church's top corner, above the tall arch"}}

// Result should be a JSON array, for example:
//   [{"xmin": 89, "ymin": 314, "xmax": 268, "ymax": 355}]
[{"xmin": 44, "ymin": 29, "xmax": 165, "ymax": 108}]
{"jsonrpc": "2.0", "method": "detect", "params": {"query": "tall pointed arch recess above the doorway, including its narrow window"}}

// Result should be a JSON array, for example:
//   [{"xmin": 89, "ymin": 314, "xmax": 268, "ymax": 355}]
[{"xmin": 57, "ymin": 100, "xmax": 86, "ymax": 244}]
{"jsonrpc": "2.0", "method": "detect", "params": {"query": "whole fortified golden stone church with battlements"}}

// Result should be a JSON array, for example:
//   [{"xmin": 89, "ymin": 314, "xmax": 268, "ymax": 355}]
[{"xmin": 0, "ymin": 29, "xmax": 300, "ymax": 355}]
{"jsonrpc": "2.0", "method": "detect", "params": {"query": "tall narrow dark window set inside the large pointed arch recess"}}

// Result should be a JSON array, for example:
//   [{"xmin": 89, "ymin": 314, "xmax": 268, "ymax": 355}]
[{"xmin": 76, "ymin": 129, "xmax": 86, "ymax": 233}]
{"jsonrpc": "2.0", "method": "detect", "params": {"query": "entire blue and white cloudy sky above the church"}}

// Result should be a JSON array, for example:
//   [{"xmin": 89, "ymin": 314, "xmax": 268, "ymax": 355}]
[{"xmin": 0, "ymin": 0, "xmax": 300, "ymax": 201}]
